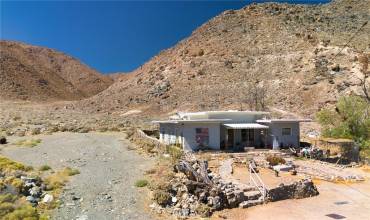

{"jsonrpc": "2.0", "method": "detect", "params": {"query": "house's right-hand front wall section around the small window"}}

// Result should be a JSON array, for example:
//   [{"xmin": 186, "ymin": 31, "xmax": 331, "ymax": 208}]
[{"xmin": 268, "ymin": 122, "xmax": 300, "ymax": 147}]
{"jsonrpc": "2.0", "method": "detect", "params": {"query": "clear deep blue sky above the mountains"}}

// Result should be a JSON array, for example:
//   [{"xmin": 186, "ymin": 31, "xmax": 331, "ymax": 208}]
[{"xmin": 0, "ymin": 0, "xmax": 328, "ymax": 73}]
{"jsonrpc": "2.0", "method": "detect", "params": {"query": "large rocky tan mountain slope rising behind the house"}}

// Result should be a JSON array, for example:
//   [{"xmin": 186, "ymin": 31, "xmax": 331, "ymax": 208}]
[{"xmin": 77, "ymin": 0, "xmax": 370, "ymax": 116}]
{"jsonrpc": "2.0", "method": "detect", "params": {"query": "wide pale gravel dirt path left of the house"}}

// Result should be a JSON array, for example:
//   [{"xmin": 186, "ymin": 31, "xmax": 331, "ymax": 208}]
[{"xmin": 1, "ymin": 133, "xmax": 153, "ymax": 220}]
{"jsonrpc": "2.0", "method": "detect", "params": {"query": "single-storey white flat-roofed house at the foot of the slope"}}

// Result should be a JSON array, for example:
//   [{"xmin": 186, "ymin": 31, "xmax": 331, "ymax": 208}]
[{"xmin": 153, "ymin": 111, "xmax": 309, "ymax": 150}]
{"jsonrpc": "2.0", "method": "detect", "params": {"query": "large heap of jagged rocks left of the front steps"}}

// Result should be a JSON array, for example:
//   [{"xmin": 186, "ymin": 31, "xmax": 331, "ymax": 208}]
[{"xmin": 152, "ymin": 160, "xmax": 263, "ymax": 217}]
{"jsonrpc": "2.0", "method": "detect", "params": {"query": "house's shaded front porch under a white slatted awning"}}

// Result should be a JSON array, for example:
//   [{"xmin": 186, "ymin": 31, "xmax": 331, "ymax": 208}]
[{"xmin": 220, "ymin": 123, "xmax": 269, "ymax": 151}]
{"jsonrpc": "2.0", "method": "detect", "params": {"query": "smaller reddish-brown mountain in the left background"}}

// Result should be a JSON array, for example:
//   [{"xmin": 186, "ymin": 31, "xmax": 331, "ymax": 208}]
[{"xmin": 0, "ymin": 40, "xmax": 113, "ymax": 101}]
